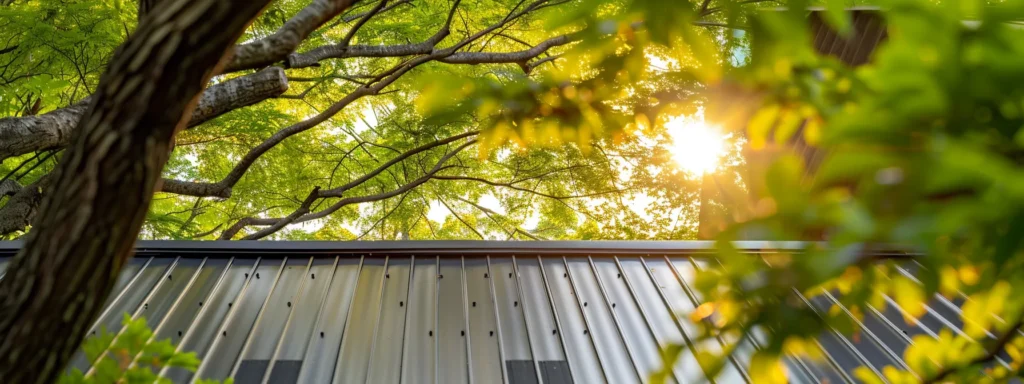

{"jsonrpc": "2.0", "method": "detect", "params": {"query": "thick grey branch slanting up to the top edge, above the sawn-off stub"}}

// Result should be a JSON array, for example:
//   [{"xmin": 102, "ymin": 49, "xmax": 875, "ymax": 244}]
[{"xmin": 225, "ymin": 0, "xmax": 357, "ymax": 72}]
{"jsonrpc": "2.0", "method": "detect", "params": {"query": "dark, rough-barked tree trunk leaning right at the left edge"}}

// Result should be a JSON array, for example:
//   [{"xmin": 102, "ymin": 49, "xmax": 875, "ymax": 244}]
[{"xmin": 0, "ymin": 0, "xmax": 269, "ymax": 383}]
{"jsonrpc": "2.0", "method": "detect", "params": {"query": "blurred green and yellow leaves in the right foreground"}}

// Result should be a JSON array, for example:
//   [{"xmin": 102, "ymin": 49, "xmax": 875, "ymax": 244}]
[{"xmin": 454, "ymin": 0, "xmax": 1024, "ymax": 383}]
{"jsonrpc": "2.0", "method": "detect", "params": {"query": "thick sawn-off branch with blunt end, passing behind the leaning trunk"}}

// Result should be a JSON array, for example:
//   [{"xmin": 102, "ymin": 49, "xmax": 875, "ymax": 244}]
[{"xmin": 0, "ymin": 68, "xmax": 288, "ymax": 161}]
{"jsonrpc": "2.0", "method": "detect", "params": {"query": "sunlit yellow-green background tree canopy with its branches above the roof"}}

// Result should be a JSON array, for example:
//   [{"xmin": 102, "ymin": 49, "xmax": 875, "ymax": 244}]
[{"xmin": 0, "ymin": 0, "xmax": 741, "ymax": 240}]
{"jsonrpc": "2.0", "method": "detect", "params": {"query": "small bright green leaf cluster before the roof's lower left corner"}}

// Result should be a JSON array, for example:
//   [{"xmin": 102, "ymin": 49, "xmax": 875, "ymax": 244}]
[{"xmin": 58, "ymin": 313, "xmax": 233, "ymax": 384}]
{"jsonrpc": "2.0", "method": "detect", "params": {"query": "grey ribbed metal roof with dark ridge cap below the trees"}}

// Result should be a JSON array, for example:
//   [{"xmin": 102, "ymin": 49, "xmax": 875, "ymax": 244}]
[{"xmin": 0, "ymin": 242, "xmax": 983, "ymax": 384}]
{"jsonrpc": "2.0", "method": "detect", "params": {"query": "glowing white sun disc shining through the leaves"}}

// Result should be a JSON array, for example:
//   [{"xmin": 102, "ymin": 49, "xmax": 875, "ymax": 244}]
[{"xmin": 665, "ymin": 117, "xmax": 726, "ymax": 175}]
